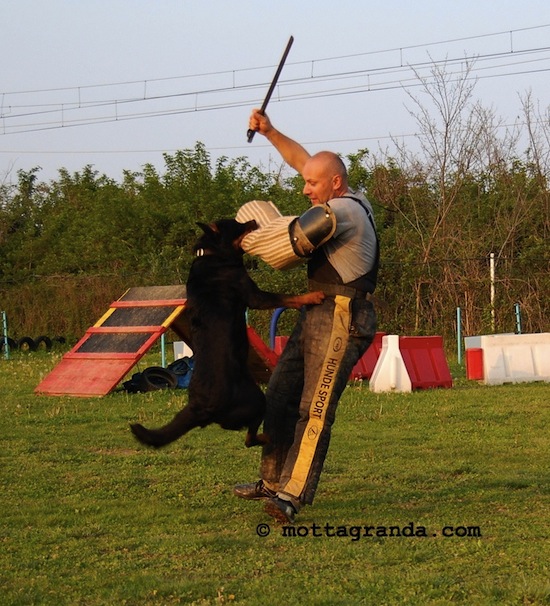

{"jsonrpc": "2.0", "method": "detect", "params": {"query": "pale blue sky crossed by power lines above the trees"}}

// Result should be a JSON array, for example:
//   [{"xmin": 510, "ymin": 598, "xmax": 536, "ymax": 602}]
[{"xmin": 0, "ymin": 0, "xmax": 550, "ymax": 183}]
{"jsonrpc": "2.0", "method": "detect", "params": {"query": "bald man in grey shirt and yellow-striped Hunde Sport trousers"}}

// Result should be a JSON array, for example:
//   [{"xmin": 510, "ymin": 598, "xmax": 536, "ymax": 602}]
[{"xmin": 234, "ymin": 110, "xmax": 379, "ymax": 523}]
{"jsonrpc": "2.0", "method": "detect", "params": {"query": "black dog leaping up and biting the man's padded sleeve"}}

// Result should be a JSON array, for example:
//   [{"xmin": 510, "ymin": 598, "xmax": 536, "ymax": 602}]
[{"xmin": 131, "ymin": 219, "xmax": 324, "ymax": 447}]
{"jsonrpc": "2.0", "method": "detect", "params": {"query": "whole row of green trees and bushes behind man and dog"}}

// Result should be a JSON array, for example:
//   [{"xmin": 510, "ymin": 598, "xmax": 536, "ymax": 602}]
[{"xmin": 0, "ymin": 66, "xmax": 550, "ymax": 346}]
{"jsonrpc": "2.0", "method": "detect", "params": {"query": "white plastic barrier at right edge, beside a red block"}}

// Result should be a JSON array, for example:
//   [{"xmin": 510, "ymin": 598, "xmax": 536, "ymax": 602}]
[{"xmin": 481, "ymin": 333, "xmax": 550, "ymax": 385}]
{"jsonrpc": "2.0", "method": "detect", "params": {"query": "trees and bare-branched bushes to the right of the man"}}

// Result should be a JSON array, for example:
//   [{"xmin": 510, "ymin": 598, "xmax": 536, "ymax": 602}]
[{"xmin": 351, "ymin": 65, "xmax": 550, "ymax": 336}]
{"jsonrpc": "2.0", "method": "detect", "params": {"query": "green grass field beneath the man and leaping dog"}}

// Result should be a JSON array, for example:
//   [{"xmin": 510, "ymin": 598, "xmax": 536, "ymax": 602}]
[{"xmin": 0, "ymin": 353, "xmax": 550, "ymax": 606}]
